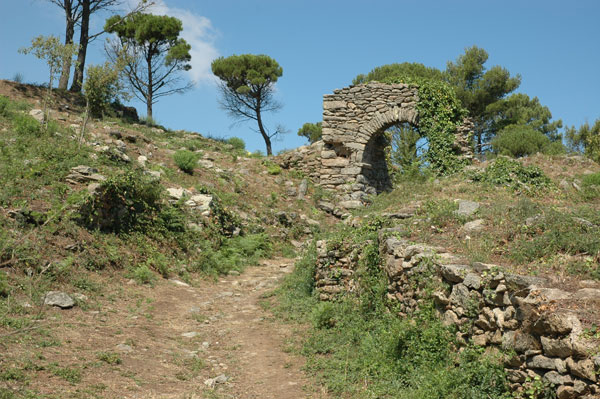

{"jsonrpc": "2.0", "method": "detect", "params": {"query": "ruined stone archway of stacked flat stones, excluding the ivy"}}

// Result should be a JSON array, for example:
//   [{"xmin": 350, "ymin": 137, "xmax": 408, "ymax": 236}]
[{"xmin": 320, "ymin": 82, "xmax": 473, "ymax": 208}]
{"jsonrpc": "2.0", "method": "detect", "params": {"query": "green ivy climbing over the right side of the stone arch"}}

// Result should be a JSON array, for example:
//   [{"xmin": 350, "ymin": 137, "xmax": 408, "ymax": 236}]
[{"xmin": 383, "ymin": 77, "xmax": 467, "ymax": 175}]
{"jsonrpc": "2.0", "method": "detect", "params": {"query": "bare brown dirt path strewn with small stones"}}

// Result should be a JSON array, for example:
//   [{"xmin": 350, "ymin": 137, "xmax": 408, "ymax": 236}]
[{"xmin": 4, "ymin": 259, "xmax": 324, "ymax": 399}]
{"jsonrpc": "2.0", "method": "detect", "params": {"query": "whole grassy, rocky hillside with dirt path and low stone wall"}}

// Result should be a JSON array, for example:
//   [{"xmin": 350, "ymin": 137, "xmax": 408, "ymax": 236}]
[{"xmin": 0, "ymin": 81, "xmax": 600, "ymax": 399}]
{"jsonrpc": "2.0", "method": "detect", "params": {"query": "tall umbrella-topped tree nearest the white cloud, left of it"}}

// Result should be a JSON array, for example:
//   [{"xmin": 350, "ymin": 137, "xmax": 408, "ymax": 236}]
[{"xmin": 104, "ymin": 13, "xmax": 192, "ymax": 120}]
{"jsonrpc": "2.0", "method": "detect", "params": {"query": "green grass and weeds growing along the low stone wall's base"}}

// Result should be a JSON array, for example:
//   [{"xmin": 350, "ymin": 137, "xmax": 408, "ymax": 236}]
[{"xmin": 275, "ymin": 228, "xmax": 509, "ymax": 399}]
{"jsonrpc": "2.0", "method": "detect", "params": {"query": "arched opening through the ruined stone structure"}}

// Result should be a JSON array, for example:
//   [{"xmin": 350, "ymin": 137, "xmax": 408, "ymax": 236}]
[{"xmin": 361, "ymin": 122, "xmax": 429, "ymax": 194}]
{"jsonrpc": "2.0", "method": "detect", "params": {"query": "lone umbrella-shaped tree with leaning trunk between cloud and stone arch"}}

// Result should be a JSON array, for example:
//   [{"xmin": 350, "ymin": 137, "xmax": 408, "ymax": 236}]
[{"xmin": 211, "ymin": 54, "xmax": 283, "ymax": 155}]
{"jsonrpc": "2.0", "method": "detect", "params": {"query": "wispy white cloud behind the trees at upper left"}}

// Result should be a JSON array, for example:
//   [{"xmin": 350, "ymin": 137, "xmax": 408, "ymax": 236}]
[{"xmin": 128, "ymin": 0, "xmax": 219, "ymax": 83}]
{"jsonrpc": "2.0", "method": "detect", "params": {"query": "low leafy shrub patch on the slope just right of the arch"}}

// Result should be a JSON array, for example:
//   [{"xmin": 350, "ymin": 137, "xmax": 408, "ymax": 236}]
[{"xmin": 469, "ymin": 157, "xmax": 552, "ymax": 195}]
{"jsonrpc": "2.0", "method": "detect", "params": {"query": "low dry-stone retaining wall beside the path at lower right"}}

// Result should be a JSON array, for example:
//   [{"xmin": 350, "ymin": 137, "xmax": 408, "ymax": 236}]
[{"xmin": 315, "ymin": 231, "xmax": 600, "ymax": 399}]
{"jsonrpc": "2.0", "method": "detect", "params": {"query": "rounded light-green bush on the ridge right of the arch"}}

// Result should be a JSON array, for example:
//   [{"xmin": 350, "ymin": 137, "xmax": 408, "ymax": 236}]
[{"xmin": 492, "ymin": 125, "xmax": 564, "ymax": 158}]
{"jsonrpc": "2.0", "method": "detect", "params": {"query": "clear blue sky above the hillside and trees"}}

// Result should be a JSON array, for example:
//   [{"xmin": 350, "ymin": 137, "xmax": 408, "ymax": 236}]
[{"xmin": 0, "ymin": 0, "xmax": 600, "ymax": 151}]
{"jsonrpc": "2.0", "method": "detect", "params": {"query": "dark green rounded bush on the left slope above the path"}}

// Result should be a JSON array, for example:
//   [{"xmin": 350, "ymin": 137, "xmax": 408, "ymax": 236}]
[{"xmin": 80, "ymin": 171, "xmax": 163, "ymax": 233}]
